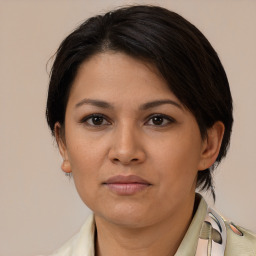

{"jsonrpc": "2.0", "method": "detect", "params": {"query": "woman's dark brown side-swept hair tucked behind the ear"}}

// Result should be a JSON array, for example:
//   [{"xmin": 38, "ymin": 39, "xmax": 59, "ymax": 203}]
[{"xmin": 46, "ymin": 5, "xmax": 233, "ymax": 198}]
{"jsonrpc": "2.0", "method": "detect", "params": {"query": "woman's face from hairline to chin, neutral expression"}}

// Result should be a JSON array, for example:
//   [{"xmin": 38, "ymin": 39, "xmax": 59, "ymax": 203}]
[{"xmin": 59, "ymin": 53, "xmax": 207, "ymax": 227}]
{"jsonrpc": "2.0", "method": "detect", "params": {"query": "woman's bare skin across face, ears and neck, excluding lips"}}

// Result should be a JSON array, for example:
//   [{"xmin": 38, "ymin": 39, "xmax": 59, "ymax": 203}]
[{"xmin": 55, "ymin": 52, "xmax": 224, "ymax": 256}]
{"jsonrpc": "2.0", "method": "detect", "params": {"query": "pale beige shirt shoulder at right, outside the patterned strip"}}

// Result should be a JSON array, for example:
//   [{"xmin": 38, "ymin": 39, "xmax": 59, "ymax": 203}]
[{"xmin": 225, "ymin": 220, "xmax": 256, "ymax": 256}]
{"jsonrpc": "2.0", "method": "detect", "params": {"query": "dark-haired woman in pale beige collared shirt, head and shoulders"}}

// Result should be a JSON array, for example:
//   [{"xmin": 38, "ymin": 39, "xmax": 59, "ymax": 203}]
[{"xmin": 46, "ymin": 6, "xmax": 256, "ymax": 256}]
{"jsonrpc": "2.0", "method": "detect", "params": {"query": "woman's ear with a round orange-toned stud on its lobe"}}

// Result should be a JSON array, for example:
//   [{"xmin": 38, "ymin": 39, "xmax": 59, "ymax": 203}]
[{"xmin": 54, "ymin": 122, "xmax": 72, "ymax": 173}]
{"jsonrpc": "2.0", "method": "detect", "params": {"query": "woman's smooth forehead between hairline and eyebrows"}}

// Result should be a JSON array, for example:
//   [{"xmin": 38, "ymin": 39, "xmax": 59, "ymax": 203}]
[{"xmin": 67, "ymin": 52, "xmax": 178, "ymax": 104}]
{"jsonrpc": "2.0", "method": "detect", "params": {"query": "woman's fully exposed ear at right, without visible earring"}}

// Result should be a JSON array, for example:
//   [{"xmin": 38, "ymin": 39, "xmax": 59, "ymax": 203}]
[{"xmin": 198, "ymin": 121, "xmax": 225, "ymax": 171}]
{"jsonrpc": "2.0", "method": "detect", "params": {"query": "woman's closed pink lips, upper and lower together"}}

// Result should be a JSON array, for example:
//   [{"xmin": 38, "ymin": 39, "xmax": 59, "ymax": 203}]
[{"xmin": 103, "ymin": 175, "xmax": 152, "ymax": 195}]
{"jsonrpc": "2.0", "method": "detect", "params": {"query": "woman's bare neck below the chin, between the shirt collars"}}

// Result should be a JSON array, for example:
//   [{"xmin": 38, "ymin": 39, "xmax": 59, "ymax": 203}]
[{"xmin": 95, "ymin": 194, "xmax": 195, "ymax": 256}]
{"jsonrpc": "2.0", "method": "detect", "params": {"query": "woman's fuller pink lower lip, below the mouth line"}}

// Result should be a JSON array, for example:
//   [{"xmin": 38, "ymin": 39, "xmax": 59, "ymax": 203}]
[{"xmin": 105, "ymin": 183, "xmax": 150, "ymax": 195}]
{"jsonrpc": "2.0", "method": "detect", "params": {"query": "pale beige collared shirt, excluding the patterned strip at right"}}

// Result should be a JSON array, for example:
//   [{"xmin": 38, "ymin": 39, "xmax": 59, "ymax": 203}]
[{"xmin": 47, "ymin": 197, "xmax": 256, "ymax": 256}]
